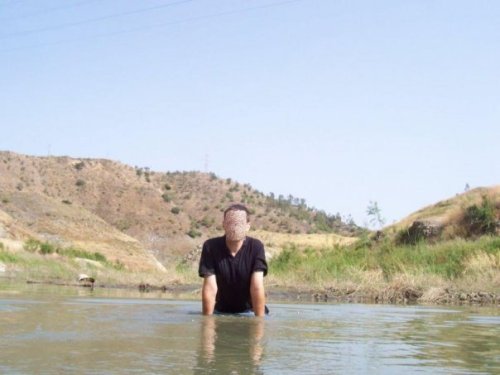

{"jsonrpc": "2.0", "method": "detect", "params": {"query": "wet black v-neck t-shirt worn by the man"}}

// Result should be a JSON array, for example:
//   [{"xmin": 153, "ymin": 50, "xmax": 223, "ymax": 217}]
[{"xmin": 198, "ymin": 236, "xmax": 267, "ymax": 313}]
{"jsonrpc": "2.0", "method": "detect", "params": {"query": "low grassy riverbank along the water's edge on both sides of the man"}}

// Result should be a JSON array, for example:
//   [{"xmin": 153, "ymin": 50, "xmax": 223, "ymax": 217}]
[{"xmin": 0, "ymin": 236, "xmax": 500, "ymax": 306}]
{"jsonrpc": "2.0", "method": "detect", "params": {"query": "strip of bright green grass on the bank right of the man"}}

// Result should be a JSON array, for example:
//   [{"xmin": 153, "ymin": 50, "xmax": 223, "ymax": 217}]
[{"xmin": 269, "ymin": 236, "xmax": 500, "ymax": 282}]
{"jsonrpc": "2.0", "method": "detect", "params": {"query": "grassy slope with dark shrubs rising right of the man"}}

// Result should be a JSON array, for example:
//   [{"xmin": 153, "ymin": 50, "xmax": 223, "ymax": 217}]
[{"xmin": 270, "ymin": 191, "xmax": 500, "ymax": 301}]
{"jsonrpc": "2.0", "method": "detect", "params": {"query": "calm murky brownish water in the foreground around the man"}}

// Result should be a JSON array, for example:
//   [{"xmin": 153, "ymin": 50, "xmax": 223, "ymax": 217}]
[{"xmin": 0, "ymin": 281, "xmax": 500, "ymax": 374}]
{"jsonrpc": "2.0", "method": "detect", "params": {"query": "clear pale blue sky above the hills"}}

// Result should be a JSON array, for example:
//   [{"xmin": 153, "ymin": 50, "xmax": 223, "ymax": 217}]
[{"xmin": 0, "ymin": 0, "xmax": 500, "ymax": 225}]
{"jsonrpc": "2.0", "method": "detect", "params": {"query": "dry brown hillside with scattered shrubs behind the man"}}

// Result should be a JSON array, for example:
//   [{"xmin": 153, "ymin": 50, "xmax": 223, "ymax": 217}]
[{"xmin": 0, "ymin": 152, "xmax": 359, "ymax": 269}]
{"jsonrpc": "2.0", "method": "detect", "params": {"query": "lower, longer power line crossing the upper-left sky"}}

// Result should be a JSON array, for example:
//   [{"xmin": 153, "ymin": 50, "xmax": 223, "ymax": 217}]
[{"xmin": 0, "ymin": 0, "xmax": 305, "ymax": 53}]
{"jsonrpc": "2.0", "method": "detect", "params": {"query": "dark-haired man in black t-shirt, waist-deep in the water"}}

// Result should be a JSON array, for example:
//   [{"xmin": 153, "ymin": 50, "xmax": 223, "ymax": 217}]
[{"xmin": 198, "ymin": 204, "xmax": 267, "ymax": 316}]
